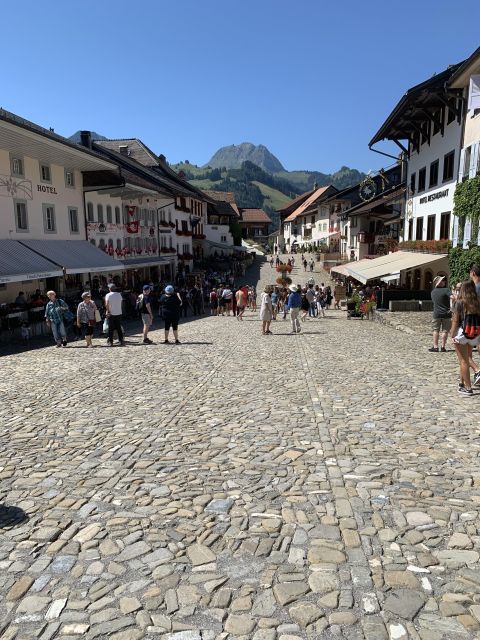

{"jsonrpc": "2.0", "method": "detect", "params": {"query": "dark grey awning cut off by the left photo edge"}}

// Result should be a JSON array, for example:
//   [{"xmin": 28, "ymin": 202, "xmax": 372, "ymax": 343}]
[{"xmin": 0, "ymin": 239, "xmax": 63, "ymax": 284}]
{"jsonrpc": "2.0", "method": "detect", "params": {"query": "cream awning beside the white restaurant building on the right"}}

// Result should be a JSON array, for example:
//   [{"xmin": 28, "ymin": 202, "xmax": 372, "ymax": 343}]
[{"xmin": 346, "ymin": 251, "xmax": 447, "ymax": 284}]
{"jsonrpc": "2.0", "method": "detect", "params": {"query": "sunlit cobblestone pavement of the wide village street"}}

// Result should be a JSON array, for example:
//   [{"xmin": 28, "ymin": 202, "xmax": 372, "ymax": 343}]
[{"xmin": 0, "ymin": 264, "xmax": 480, "ymax": 640}]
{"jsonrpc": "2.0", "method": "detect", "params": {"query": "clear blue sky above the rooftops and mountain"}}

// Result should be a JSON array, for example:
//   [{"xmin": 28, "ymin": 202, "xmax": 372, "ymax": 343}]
[{"xmin": 0, "ymin": 0, "xmax": 480, "ymax": 172}]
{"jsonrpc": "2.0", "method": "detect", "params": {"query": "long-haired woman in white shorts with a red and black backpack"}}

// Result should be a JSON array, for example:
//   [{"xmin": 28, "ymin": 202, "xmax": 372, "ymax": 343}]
[{"xmin": 451, "ymin": 280, "xmax": 480, "ymax": 397}]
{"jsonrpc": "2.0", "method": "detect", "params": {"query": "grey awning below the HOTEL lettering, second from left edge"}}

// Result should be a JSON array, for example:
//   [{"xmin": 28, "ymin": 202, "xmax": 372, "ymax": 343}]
[{"xmin": 19, "ymin": 240, "xmax": 125, "ymax": 274}]
